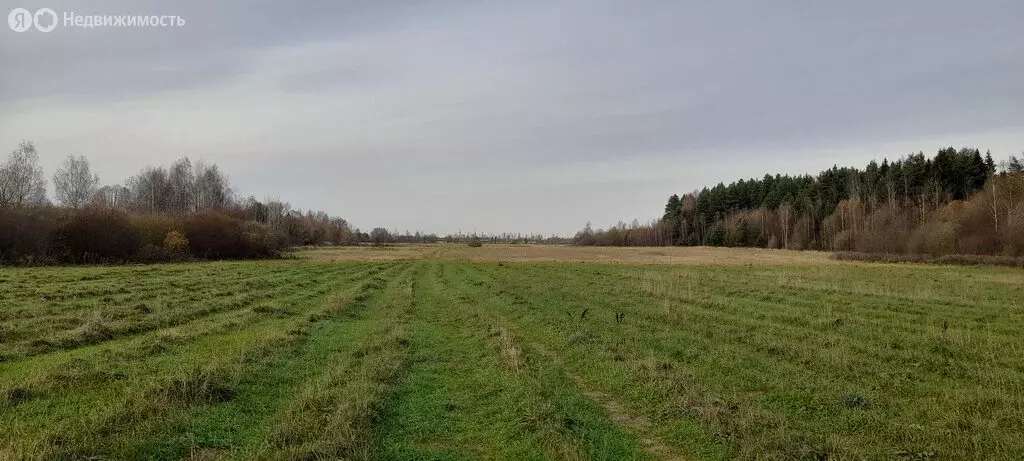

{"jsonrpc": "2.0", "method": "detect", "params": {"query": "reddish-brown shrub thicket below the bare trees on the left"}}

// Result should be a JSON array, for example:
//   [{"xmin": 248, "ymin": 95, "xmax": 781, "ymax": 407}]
[{"xmin": 0, "ymin": 206, "xmax": 286, "ymax": 264}]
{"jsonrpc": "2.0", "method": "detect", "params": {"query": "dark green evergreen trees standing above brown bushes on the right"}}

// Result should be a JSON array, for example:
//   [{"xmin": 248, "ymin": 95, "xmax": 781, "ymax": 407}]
[{"xmin": 659, "ymin": 148, "xmax": 1003, "ymax": 248}]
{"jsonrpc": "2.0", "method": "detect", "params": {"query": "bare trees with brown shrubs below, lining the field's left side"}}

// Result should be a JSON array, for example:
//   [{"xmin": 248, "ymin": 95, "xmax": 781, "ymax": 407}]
[{"xmin": 0, "ymin": 141, "xmax": 370, "ymax": 263}]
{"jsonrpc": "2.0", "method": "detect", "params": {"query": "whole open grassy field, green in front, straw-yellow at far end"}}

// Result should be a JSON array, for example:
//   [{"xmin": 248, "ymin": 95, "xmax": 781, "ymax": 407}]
[{"xmin": 0, "ymin": 246, "xmax": 1024, "ymax": 460}]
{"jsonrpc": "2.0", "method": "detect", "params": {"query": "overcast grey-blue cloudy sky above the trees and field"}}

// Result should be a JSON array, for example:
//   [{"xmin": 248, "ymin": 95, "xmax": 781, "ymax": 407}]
[{"xmin": 0, "ymin": 0, "xmax": 1024, "ymax": 235}]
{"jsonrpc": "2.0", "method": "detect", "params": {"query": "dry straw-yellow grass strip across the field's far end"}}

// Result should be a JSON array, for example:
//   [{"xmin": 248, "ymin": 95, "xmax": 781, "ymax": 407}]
[{"xmin": 298, "ymin": 244, "xmax": 839, "ymax": 265}]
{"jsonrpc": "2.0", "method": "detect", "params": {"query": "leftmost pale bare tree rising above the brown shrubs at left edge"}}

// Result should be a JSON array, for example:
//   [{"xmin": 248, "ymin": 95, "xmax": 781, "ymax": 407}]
[{"xmin": 0, "ymin": 141, "xmax": 46, "ymax": 208}]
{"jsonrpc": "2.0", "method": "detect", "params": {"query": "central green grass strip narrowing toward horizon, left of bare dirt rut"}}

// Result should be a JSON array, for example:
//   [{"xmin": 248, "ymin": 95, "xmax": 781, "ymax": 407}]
[{"xmin": 372, "ymin": 261, "xmax": 656, "ymax": 460}]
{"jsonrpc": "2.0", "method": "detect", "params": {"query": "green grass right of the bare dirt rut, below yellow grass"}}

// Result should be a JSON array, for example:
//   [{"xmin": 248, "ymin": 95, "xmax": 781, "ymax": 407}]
[{"xmin": 462, "ymin": 264, "xmax": 1024, "ymax": 459}]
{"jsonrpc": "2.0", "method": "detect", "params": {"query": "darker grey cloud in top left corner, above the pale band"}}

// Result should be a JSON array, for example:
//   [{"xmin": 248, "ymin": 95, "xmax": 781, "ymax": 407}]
[{"xmin": 0, "ymin": 0, "xmax": 456, "ymax": 102}]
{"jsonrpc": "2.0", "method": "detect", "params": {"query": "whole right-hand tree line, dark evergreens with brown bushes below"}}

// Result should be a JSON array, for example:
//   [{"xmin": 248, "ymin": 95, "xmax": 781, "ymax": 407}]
[{"xmin": 573, "ymin": 148, "xmax": 1024, "ymax": 256}]
